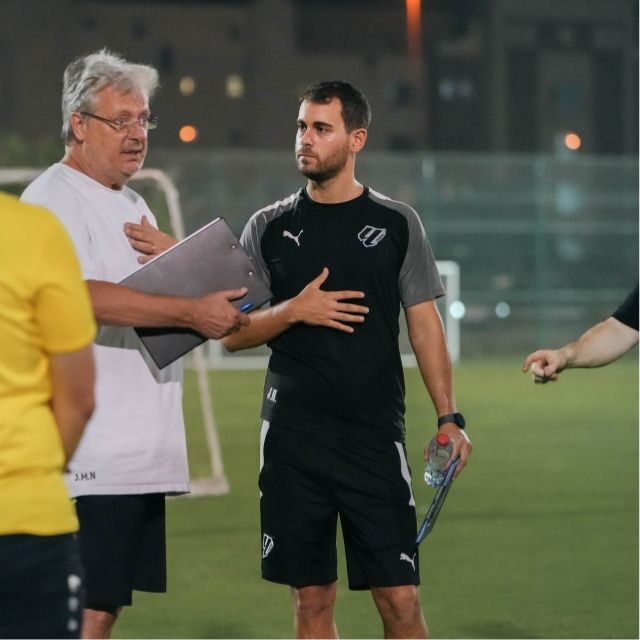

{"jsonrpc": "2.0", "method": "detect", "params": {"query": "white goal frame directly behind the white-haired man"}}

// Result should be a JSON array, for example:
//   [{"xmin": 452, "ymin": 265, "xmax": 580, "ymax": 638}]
[{"xmin": 0, "ymin": 168, "xmax": 229, "ymax": 496}]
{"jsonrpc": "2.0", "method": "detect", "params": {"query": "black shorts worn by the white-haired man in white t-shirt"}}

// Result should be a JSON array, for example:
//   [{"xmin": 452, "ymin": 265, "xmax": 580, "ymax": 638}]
[{"xmin": 76, "ymin": 493, "xmax": 167, "ymax": 610}]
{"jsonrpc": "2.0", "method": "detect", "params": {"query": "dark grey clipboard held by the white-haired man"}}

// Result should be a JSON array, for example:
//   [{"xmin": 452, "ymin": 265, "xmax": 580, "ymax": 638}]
[{"xmin": 119, "ymin": 218, "xmax": 273, "ymax": 369}]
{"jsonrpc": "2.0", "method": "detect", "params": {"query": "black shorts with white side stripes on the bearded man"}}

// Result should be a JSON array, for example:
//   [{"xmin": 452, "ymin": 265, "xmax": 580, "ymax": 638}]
[{"xmin": 259, "ymin": 422, "xmax": 420, "ymax": 590}]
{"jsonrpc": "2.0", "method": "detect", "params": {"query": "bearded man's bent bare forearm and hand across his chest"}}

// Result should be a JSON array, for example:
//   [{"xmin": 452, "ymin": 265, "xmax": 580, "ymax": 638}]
[{"xmin": 223, "ymin": 267, "xmax": 369, "ymax": 351}]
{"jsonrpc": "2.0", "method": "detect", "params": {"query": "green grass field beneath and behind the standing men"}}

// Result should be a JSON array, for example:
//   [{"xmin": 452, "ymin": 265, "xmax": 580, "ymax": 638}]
[{"xmin": 114, "ymin": 354, "xmax": 638, "ymax": 638}]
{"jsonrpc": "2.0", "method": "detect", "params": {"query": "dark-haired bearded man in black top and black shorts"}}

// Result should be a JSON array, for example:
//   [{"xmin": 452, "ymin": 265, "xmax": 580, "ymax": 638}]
[{"xmin": 225, "ymin": 82, "xmax": 471, "ymax": 638}]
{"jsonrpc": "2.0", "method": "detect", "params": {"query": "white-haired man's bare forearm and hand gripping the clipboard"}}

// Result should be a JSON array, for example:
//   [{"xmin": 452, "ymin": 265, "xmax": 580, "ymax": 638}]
[{"xmin": 87, "ymin": 280, "xmax": 250, "ymax": 339}]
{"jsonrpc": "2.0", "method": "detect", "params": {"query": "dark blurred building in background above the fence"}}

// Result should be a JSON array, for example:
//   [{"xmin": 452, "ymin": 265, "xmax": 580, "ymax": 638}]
[{"xmin": 0, "ymin": 0, "xmax": 638, "ymax": 154}]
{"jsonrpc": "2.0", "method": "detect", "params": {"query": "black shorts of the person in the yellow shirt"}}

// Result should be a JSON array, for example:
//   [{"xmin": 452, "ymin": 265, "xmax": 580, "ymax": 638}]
[{"xmin": 0, "ymin": 533, "xmax": 84, "ymax": 638}]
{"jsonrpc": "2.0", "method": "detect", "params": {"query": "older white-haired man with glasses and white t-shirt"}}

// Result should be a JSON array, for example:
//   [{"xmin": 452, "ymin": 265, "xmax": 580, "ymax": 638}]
[{"xmin": 22, "ymin": 50, "xmax": 249, "ymax": 638}]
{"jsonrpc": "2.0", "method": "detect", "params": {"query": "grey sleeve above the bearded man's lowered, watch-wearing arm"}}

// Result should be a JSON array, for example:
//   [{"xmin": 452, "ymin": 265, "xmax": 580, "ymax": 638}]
[{"xmin": 398, "ymin": 207, "xmax": 444, "ymax": 308}]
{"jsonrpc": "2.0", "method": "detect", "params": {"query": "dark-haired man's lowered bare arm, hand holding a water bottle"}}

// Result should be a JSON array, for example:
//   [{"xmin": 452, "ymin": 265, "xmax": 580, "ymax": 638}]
[{"xmin": 405, "ymin": 300, "xmax": 472, "ymax": 476}]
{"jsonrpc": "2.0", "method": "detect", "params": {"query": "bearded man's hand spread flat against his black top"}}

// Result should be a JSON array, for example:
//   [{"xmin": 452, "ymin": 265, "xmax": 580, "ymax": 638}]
[{"xmin": 290, "ymin": 267, "xmax": 369, "ymax": 333}]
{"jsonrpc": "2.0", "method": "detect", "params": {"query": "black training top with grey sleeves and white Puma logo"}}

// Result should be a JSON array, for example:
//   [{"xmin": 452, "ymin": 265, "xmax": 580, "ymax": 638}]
[{"xmin": 241, "ymin": 188, "xmax": 444, "ymax": 441}]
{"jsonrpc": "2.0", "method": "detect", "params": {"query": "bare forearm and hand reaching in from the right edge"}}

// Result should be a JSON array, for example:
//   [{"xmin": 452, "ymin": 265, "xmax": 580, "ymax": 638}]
[{"xmin": 522, "ymin": 317, "xmax": 638, "ymax": 384}]
